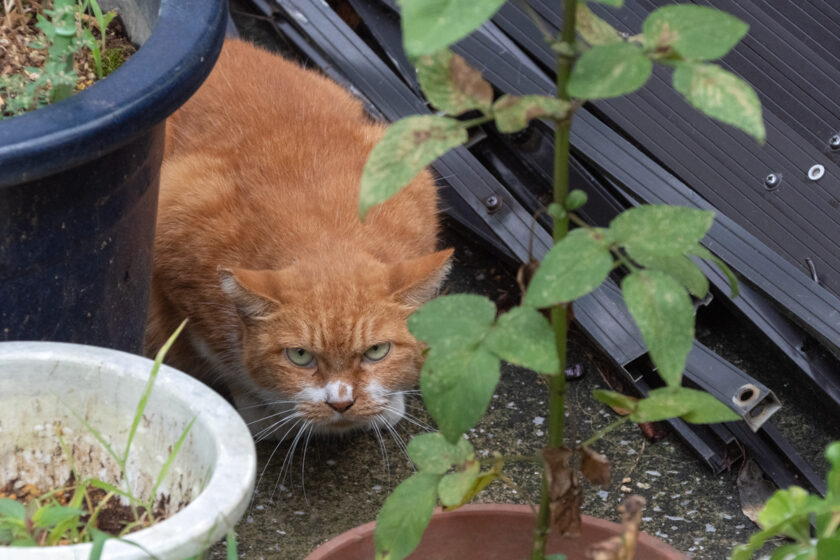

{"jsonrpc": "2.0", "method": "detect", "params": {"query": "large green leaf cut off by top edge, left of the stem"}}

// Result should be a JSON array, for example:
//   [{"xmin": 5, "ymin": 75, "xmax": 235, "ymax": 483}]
[{"xmin": 400, "ymin": 0, "xmax": 505, "ymax": 57}]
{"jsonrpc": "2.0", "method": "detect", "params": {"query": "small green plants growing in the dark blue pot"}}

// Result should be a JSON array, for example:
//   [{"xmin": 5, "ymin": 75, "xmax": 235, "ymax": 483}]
[{"xmin": 0, "ymin": 0, "xmax": 122, "ymax": 119}]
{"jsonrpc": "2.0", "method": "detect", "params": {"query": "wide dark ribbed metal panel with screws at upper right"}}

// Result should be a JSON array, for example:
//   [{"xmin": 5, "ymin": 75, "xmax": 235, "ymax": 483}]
[{"xmin": 514, "ymin": 0, "xmax": 840, "ymax": 302}]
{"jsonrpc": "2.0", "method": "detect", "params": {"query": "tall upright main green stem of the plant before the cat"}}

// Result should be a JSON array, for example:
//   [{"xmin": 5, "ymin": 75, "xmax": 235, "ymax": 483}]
[{"xmin": 531, "ymin": 0, "xmax": 577, "ymax": 560}]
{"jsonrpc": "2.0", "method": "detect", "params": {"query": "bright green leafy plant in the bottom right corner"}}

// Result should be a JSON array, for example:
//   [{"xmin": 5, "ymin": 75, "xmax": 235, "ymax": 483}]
[{"xmin": 732, "ymin": 441, "xmax": 840, "ymax": 560}]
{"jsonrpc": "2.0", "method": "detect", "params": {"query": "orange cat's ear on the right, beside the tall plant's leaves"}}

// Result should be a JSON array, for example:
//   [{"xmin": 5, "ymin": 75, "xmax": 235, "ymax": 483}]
[{"xmin": 388, "ymin": 249, "xmax": 454, "ymax": 307}]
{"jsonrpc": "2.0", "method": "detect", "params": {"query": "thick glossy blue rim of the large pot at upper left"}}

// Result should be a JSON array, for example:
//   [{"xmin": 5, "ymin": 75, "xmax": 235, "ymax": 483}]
[{"xmin": 0, "ymin": 0, "xmax": 227, "ymax": 188}]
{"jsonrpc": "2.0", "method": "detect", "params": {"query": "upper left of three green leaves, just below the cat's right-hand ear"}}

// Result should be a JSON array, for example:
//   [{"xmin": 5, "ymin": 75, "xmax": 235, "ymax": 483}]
[{"xmin": 408, "ymin": 294, "xmax": 496, "ymax": 354}]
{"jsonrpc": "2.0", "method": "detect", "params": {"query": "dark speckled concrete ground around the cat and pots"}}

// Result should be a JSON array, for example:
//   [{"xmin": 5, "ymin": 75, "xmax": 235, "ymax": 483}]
[{"xmin": 210, "ymin": 6, "xmax": 840, "ymax": 560}]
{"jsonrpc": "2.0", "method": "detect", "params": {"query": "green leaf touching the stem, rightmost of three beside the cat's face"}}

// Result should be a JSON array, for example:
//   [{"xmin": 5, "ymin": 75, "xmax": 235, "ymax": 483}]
[{"xmin": 484, "ymin": 307, "xmax": 560, "ymax": 374}]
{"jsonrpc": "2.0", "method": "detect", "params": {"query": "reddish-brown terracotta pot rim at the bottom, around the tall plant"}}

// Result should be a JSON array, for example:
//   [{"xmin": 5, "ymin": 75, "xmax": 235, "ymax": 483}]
[{"xmin": 304, "ymin": 504, "xmax": 681, "ymax": 560}]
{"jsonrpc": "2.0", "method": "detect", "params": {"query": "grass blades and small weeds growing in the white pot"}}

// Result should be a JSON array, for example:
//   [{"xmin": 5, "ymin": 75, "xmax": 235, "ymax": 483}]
[{"xmin": 0, "ymin": 322, "xmax": 236, "ymax": 560}]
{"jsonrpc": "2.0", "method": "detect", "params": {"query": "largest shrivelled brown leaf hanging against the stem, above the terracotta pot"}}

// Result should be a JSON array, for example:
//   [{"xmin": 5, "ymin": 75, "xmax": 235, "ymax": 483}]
[{"xmin": 542, "ymin": 447, "xmax": 582, "ymax": 536}]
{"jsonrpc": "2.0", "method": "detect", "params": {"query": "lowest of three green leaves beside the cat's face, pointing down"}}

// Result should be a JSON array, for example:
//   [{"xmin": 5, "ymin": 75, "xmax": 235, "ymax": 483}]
[{"xmin": 420, "ymin": 348, "xmax": 500, "ymax": 443}]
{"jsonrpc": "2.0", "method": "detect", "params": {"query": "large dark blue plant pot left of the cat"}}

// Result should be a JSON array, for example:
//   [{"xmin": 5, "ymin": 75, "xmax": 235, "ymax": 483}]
[{"xmin": 0, "ymin": 0, "xmax": 227, "ymax": 352}]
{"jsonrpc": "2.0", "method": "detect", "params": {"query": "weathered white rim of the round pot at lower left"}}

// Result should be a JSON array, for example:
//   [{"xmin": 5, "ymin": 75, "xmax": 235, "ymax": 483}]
[{"xmin": 0, "ymin": 342, "xmax": 257, "ymax": 560}]
